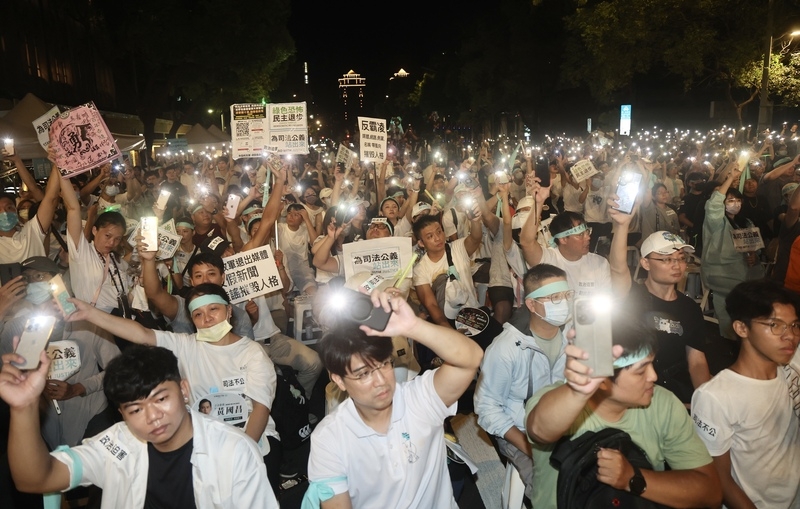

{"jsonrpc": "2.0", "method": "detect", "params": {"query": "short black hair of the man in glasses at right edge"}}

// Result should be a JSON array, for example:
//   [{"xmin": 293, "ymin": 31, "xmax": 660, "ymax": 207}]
[{"xmin": 725, "ymin": 280, "xmax": 798, "ymax": 327}]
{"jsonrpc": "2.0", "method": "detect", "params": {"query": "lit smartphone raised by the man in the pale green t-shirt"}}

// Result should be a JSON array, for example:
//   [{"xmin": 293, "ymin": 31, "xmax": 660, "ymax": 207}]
[{"xmin": 572, "ymin": 295, "xmax": 614, "ymax": 377}]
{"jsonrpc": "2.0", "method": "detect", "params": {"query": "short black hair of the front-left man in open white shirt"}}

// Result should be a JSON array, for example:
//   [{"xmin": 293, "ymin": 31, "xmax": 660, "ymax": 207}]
[{"xmin": 103, "ymin": 345, "xmax": 181, "ymax": 408}]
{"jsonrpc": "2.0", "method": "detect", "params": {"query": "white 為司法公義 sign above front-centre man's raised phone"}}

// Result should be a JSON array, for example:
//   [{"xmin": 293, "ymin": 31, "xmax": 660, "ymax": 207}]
[{"xmin": 342, "ymin": 237, "xmax": 412, "ymax": 279}]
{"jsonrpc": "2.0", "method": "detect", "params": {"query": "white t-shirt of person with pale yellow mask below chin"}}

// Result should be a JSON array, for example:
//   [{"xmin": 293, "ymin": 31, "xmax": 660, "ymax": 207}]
[{"xmin": 154, "ymin": 331, "xmax": 278, "ymax": 455}]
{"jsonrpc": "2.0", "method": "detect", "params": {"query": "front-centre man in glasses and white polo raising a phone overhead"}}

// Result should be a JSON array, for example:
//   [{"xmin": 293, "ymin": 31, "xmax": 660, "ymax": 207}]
[{"xmin": 303, "ymin": 288, "xmax": 483, "ymax": 509}]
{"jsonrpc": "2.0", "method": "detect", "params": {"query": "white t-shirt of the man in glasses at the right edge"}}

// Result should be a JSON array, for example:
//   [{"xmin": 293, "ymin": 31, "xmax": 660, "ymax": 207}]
[{"xmin": 692, "ymin": 368, "xmax": 800, "ymax": 509}]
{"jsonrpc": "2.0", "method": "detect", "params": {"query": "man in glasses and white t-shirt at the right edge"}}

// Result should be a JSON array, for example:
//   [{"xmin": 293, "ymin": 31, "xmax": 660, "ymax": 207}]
[{"xmin": 692, "ymin": 281, "xmax": 800, "ymax": 508}]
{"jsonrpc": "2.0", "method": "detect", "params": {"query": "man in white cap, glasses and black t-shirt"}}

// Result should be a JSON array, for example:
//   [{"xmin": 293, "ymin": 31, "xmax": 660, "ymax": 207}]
[{"xmin": 625, "ymin": 231, "xmax": 711, "ymax": 407}]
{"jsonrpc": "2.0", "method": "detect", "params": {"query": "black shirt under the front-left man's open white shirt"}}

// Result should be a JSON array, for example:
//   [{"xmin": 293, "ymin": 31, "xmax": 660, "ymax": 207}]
[{"xmin": 144, "ymin": 439, "xmax": 196, "ymax": 509}]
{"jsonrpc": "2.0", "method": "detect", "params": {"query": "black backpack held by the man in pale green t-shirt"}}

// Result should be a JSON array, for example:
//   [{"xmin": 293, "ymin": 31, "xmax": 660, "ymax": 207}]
[{"xmin": 550, "ymin": 428, "xmax": 666, "ymax": 509}]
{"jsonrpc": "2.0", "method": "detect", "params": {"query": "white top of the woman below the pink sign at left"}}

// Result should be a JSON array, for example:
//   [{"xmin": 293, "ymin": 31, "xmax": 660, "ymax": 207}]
[{"xmin": 66, "ymin": 232, "xmax": 130, "ymax": 312}]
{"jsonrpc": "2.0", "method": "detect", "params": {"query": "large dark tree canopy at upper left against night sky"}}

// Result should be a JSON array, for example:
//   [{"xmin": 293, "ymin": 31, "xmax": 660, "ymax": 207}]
[{"xmin": 96, "ymin": 0, "xmax": 294, "ymax": 161}]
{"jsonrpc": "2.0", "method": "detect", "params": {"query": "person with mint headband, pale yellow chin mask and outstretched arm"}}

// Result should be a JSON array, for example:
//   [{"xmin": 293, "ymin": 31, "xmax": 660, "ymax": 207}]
[{"xmin": 67, "ymin": 283, "xmax": 281, "ymax": 493}]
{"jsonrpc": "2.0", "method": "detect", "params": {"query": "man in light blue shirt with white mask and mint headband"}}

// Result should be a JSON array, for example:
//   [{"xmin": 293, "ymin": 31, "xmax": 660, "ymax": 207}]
[{"xmin": 475, "ymin": 263, "xmax": 575, "ymax": 497}]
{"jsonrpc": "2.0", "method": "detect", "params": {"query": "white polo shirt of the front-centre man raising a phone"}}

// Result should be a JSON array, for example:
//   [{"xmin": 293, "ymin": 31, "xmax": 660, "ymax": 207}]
[{"xmin": 308, "ymin": 370, "xmax": 458, "ymax": 509}]
